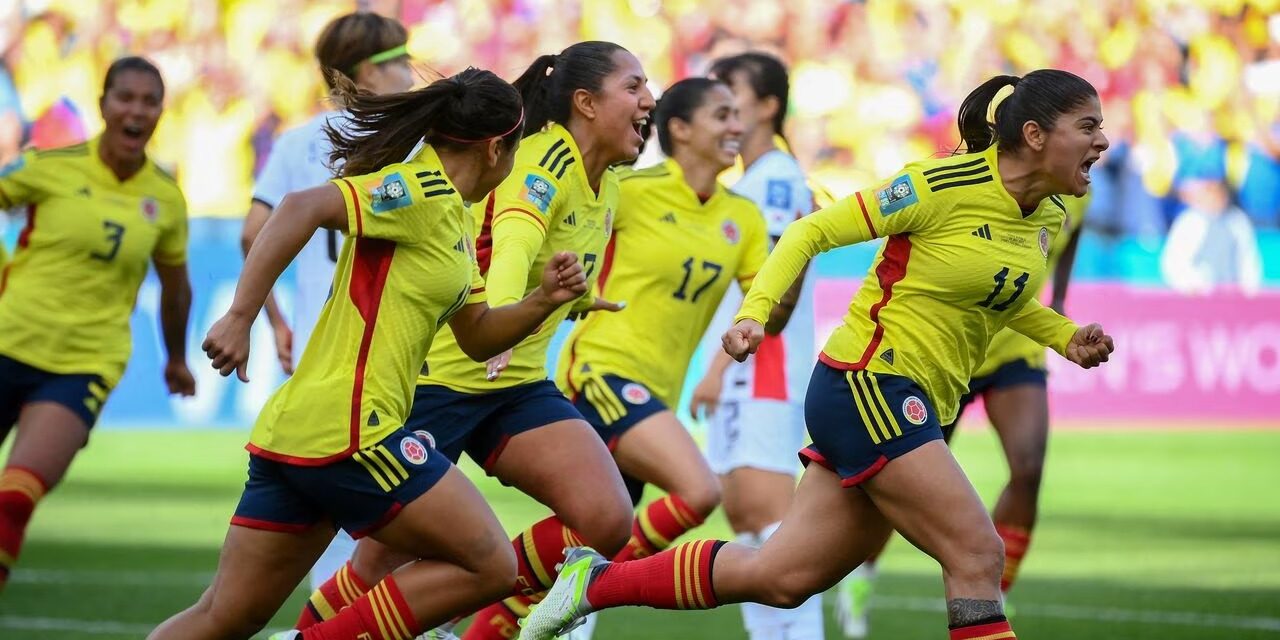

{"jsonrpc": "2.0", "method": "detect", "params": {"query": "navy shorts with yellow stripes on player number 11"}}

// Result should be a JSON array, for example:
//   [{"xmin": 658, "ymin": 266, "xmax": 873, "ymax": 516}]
[{"xmin": 800, "ymin": 362, "xmax": 942, "ymax": 486}]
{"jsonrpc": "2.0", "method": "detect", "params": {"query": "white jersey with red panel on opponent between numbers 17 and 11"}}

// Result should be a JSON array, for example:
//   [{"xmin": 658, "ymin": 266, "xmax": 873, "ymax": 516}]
[{"xmin": 704, "ymin": 150, "xmax": 814, "ymax": 406}]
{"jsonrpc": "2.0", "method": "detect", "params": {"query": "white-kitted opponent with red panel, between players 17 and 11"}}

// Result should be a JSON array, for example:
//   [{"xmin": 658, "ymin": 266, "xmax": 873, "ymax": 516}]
[{"xmin": 690, "ymin": 52, "xmax": 823, "ymax": 640}]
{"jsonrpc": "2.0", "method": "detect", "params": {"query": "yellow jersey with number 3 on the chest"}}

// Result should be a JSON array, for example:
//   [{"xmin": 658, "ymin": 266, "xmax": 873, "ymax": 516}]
[{"xmin": 0, "ymin": 138, "xmax": 187, "ymax": 385}]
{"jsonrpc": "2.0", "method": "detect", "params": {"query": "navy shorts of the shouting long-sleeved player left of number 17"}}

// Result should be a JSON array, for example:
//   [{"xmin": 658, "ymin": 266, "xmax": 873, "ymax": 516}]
[{"xmin": 404, "ymin": 380, "xmax": 582, "ymax": 471}]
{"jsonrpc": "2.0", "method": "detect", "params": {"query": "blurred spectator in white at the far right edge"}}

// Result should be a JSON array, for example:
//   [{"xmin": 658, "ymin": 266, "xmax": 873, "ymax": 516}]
[{"xmin": 1160, "ymin": 179, "xmax": 1262, "ymax": 294}]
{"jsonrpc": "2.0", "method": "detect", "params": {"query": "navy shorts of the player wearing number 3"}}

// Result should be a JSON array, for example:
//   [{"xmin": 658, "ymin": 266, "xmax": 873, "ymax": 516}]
[{"xmin": 0, "ymin": 356, "xmax": 111, "ymax": 442}]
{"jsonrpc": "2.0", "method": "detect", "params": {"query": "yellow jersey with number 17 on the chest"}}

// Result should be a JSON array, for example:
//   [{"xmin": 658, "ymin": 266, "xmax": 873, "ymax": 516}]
[{"xmin": 556, "ymin": 160, "xmax": 769, "ymax": 407}]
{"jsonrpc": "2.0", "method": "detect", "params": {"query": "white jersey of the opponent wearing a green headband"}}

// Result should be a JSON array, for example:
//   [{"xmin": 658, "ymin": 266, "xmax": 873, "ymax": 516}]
[{"xmin": 253, "ymin": 111, "xmax": 343, "ymax": 365}]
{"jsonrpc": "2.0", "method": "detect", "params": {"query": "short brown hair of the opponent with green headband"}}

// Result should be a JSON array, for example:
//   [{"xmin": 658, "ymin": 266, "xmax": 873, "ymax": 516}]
[{"xmin": 315, "ymin": 12, "xmax": 408, "ymax": 90}]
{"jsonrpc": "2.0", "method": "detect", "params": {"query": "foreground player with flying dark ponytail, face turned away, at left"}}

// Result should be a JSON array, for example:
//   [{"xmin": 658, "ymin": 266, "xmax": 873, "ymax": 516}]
[{"xmin": 150, "ymin": 69, "xmax": 586, "ymax": 640}]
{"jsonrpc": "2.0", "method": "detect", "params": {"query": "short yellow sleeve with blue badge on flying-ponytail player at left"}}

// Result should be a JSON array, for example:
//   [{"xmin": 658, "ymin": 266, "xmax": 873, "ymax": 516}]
[{"xmin": 332, "ymin": 164, "xmax": 450, "ymax": 244}]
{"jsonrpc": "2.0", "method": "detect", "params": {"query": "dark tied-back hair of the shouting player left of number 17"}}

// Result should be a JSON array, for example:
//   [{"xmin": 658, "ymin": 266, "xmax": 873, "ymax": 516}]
[{"xmin": 512, "ymin": 40, "xmax": 626, "ymax": 134}]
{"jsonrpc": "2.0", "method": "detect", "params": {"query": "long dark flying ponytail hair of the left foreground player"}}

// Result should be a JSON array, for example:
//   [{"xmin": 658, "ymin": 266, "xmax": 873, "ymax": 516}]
[{"xmin": 325, "ymin": 67, "xmax": 524, "ymax": 175}]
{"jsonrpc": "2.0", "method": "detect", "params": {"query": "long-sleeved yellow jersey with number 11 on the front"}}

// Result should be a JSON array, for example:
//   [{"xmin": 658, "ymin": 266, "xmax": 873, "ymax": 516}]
[{"xmin": 739, "ymin": 146, "xmax": 1075, "ymax": 424}]
